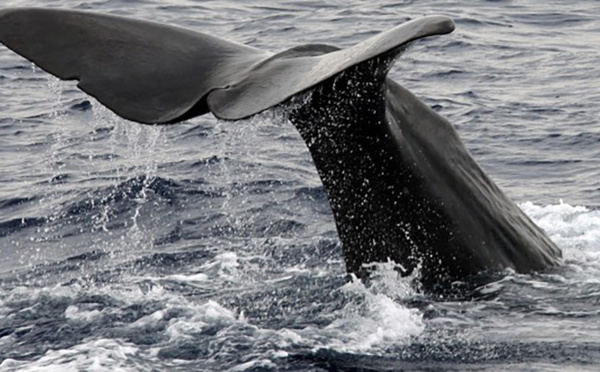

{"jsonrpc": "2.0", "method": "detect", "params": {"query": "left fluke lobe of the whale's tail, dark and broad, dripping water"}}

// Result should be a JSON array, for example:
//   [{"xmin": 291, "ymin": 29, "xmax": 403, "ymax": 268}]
[{"xmin": 0, "ymin": 8, "xmax": 270, "ymax": 124}]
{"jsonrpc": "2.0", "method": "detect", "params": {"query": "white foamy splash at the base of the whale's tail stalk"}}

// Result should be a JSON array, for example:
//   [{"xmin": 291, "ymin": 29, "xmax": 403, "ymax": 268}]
[{"xmin": 253, "ymin": 264, "xmax": 425, "ymax": 358}]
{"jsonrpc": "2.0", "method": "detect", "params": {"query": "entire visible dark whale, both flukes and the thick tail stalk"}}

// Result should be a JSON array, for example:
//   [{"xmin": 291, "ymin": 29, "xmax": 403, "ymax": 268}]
[{"xmin": 0, "ymin": 8, "xmax": 561, "ymax": 288}]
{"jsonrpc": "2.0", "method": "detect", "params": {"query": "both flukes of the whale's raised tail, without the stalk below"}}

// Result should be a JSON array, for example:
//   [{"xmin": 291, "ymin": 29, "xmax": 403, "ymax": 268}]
[{"xmin": 0, "ymin": 8, "xmax": 454, "ymax": 124}]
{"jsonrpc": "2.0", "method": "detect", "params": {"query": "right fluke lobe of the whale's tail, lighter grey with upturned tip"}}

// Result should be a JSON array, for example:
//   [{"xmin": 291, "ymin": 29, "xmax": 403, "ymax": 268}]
[{"xmin": 208, "ymin": 16, "xmax": 454, "ymax": 120}]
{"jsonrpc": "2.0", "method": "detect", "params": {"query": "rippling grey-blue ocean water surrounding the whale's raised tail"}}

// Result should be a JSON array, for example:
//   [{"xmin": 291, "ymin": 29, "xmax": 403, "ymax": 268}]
[{"xmin": 0, "ymin": 0, "xmax": 600, "ymax": 372}]
